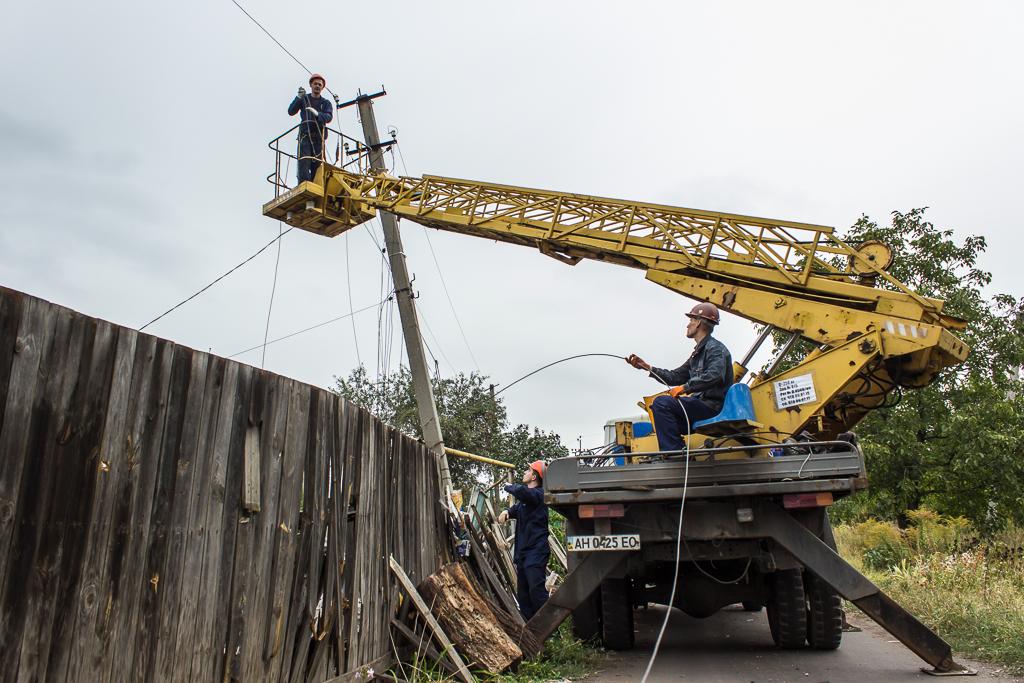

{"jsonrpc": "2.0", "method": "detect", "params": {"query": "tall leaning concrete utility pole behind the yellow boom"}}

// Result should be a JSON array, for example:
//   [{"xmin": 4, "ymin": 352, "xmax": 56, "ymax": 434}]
[{"xmin": 355, "ymin": 95, "xmax": 452, "ymax": 501}]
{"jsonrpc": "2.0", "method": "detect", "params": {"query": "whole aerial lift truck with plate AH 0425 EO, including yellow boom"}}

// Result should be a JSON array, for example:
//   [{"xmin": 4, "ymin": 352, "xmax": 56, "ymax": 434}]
[{"xmin": 263, "ymin": 100, "xmax": 970, "ymax": 674}]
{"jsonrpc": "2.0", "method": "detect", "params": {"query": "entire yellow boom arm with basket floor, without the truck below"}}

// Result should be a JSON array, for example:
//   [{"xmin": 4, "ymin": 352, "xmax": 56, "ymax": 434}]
[{"xmin": 263, "ymin": 164, "xmax": 970, "ymax": 442}]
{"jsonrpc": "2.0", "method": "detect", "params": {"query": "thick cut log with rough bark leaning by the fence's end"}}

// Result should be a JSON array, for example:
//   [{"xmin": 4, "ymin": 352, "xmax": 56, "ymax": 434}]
[{"xmin": 419, "ymin": 562, "xmax": 522, "ymax": 674}]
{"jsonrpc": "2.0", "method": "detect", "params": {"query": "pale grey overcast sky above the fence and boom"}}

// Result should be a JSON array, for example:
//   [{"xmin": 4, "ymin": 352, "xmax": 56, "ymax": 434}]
[{"xmin": 0, "ymin": 0, "xmax": 1024, "ymax": 447}]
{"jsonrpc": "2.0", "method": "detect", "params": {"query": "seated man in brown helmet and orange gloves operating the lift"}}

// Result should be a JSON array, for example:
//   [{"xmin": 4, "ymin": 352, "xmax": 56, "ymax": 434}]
[{"xmin": 626, "ymin": 302, "xmax": 732, "ymax": 451}]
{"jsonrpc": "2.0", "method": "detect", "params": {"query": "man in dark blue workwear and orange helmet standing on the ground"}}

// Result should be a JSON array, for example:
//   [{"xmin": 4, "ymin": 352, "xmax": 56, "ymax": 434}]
[{"xmin": 498, "ymin": 460, "xmax": 551, "ymax": 622}]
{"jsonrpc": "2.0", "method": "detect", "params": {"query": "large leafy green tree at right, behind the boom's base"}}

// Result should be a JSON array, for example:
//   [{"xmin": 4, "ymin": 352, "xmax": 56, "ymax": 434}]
[{"xmin": 837, "ymin": 209, "xmax": 1024, "ymax": 528}]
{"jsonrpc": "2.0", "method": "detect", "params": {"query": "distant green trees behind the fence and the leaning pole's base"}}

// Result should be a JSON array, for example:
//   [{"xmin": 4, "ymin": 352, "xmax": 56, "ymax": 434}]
[{"xmin": 334, "ymin": 366, "xmax": 569, "ymax": 488}]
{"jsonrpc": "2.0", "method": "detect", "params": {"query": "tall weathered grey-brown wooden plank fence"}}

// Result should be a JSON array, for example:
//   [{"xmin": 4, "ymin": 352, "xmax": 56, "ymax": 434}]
[{"xmin": 0, "ymin": 288, "xmax": 447, "ymax": 681}]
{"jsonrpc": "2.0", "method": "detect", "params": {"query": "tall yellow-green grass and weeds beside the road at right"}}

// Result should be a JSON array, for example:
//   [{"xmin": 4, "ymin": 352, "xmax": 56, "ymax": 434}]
[{"xmin": 836, "ymin": 509, "xmax": 1024, "ymax": 671}]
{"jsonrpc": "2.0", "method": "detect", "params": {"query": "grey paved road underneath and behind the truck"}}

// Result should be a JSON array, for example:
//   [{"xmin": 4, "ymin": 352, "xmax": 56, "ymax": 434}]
[{"xmin": 586, "ymin": 606, "xmax": 1022, "ymax": 683}]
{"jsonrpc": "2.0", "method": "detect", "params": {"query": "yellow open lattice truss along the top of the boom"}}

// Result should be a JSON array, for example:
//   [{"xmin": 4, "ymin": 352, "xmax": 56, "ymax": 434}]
[{"xmin": 352, "ymin": 176, "xmax": 872, "ymax": 284}]
